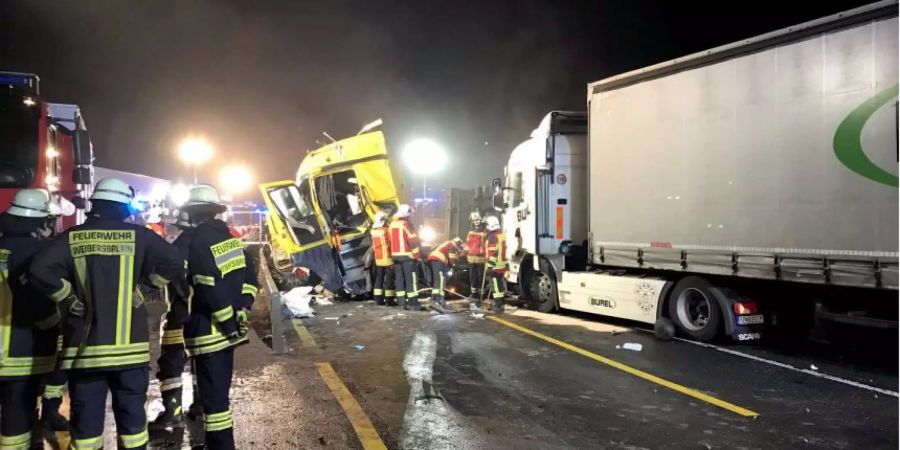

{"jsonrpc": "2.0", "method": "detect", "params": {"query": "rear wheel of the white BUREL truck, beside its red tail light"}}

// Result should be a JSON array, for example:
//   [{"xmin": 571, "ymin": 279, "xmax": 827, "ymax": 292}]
[{"xmin": 669, "ymin": 277, "xmax": 722, "ymax": 342}]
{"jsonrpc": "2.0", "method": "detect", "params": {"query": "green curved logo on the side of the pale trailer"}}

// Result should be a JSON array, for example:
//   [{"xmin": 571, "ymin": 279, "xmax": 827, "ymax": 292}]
[{"xmin": 834, "ymin": 84, "xmax": 898, "ymax": 187}]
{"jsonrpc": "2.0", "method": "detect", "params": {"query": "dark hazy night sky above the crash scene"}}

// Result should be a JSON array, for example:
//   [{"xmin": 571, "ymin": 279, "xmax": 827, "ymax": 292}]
[{"xmin": 0, "ymin": 0, "xmax": 866, "ymax": 193}]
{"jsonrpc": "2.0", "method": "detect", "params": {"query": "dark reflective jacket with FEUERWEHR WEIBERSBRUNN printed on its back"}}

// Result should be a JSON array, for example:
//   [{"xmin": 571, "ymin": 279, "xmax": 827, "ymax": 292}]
[{"xmin": 29, "ymin": 217, "xmax": 184, "ymax": 369}]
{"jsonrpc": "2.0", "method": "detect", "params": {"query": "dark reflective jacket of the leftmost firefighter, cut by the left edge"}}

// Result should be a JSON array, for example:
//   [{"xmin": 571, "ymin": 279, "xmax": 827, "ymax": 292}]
[{"xmin": 0, "ymin": 235, "xmax": 59, "ymax": 378}]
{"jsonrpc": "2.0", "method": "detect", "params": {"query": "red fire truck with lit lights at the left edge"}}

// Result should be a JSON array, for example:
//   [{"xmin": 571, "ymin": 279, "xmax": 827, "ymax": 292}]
[{"xmin": 0, "ymin": 72, "xmax": 94, "ymax": 229}]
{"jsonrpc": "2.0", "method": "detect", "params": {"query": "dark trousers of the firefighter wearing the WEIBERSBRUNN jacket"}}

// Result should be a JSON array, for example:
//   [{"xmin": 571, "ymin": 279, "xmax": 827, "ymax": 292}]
[{"xmin": 69, "ymin": 366, "xmax": 150, "ymax": 450}]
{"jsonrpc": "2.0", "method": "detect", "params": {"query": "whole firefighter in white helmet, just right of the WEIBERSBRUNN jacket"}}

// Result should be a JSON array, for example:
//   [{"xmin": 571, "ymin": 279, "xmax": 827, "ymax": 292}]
[{"xmin": 182, "ymin": 185, "xmax": 258, "ymax": 450}]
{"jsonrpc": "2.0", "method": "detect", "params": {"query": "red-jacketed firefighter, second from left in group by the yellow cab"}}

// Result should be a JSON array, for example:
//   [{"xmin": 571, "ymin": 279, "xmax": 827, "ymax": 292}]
[{"xmin": 388, "ymin": 204, "xmax": 422, "ymax": 311}]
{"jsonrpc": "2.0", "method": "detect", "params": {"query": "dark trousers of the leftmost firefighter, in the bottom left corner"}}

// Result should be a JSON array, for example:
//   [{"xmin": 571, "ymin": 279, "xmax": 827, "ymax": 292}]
[{"xmin": 0, "ymin": 376, "xmax": 41, "ymax": 450}]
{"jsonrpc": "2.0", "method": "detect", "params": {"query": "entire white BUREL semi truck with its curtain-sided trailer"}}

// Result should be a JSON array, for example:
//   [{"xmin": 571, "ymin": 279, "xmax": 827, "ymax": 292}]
[{"xmin": 503, "ymin": 1, "xmax": 898, "ymax": 340}]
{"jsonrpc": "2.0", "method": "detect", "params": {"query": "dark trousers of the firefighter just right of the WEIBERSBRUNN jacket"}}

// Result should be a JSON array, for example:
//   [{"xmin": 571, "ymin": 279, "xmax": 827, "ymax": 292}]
[{"xmin": 194, "ymin": 347, "xmax": 234, "ymax": 450}]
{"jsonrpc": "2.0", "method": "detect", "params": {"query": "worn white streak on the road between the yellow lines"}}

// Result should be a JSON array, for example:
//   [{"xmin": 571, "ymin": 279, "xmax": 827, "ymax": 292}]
[{"xmin": 401, "ymin": 332, "xmax": 475, "ymax": 449}]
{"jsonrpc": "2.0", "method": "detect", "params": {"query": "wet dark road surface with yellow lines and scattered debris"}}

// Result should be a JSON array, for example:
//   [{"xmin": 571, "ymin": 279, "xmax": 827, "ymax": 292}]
[{"xmin": 33, "ymin": 294, "xmax": 898, "ymax": 449}]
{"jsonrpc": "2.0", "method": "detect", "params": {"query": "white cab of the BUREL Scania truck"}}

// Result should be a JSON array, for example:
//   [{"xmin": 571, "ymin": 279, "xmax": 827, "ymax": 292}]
[{"xmin": 501, "ymin": 111, "xmax": 587, "ymax": 310}]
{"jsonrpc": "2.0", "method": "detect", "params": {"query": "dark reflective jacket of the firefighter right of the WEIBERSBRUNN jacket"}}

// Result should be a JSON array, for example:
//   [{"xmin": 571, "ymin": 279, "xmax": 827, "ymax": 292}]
[{"xmin": 184, "ymin": 220, "xmax": 258, "ymax": 356}]
